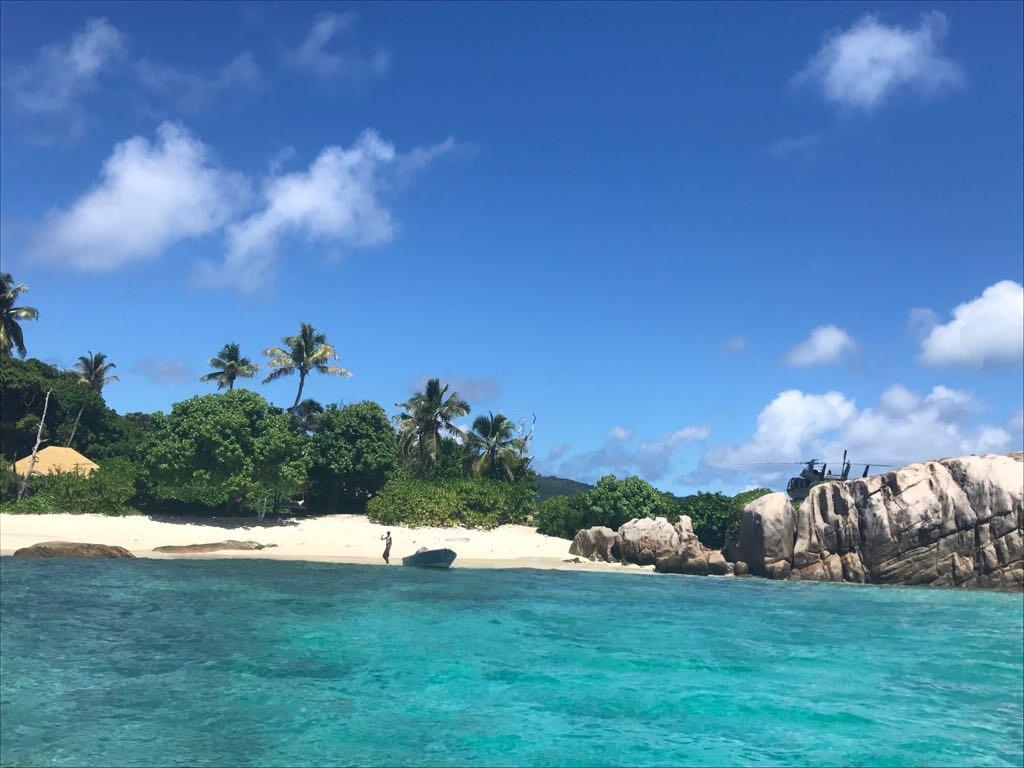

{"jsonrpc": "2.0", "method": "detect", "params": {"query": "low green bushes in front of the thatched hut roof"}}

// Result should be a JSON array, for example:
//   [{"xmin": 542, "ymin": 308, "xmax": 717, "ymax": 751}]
[{"xmin": 0, "ymin": 459, "xmax": 138, "ymax": 515}]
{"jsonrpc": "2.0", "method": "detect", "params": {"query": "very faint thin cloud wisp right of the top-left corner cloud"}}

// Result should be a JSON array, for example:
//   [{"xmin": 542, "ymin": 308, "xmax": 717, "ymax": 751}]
[{"xmin": 136, "ymin": 51, "xmax": 263, "ymax": 112}]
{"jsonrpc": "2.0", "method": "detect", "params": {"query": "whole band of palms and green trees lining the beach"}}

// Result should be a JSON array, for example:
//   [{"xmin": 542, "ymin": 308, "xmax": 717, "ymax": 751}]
[{"xmin": 0, "ymin": 274, "xmax": 767, "ymax": 547}]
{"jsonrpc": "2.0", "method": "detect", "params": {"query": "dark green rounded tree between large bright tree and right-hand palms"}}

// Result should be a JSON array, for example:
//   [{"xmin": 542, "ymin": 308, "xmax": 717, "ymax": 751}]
[{"xmin": 303, "ymin": 400, "xmax": 398, "ymax": 512}]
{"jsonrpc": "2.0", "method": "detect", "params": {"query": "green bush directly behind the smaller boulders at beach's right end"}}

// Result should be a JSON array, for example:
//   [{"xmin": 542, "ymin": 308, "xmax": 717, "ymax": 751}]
[{"xmin": 537, "ymin": 475, "xmax": 678, "ymax": 539}]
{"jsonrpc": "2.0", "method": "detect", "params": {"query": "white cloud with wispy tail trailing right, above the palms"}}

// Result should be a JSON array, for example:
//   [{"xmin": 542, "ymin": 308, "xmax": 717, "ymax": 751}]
[{"xmin": 199, "ymin": 130, "xmax": 455, "ymax": 293}]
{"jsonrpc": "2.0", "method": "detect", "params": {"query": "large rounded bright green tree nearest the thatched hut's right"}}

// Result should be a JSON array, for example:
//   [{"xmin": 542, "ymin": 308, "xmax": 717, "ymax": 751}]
[{"xmin": 145, "ymin": 389, "xmax": 310, "ymax": 512}]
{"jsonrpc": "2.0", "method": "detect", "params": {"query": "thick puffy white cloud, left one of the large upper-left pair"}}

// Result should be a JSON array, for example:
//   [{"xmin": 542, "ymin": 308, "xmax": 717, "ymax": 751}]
[{"xmin": 37, "ymin": 123, "xmax": 247, "ymax": 270}]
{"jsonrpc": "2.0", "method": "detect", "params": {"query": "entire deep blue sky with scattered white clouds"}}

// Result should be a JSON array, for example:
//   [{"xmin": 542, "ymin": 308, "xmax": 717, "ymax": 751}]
[{"xmin": 0, "ymin": 2, "xmax": 1024, "ymax": 492}]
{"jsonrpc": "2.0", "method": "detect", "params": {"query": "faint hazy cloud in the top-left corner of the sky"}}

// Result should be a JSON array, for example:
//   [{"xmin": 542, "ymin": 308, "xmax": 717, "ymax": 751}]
[{"xmin": 4, "ymin": 18, "xmax": 125, "ymax": 135}]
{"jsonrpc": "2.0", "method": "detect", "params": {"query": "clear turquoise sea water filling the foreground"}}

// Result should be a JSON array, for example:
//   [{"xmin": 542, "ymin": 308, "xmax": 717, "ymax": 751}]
[{"xmin": 0, "ymin": 558, "xmax": 1024, "ymax": 766}]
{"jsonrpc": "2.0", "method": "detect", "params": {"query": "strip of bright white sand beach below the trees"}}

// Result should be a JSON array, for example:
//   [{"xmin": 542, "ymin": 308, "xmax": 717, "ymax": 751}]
[{"xmin": 0, "ymin": 514, "xmax": 651, "ymax": 572}]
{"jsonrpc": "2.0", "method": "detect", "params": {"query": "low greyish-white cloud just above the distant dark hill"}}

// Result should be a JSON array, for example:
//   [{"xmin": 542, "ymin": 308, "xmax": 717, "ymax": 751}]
[{"xmin": 547, "ymin": 425, "xmax": 711, "ymax": 481}]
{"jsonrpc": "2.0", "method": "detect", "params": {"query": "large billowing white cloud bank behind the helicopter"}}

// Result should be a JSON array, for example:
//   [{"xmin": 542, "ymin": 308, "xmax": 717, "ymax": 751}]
[{"xmin": 699, "ymin": 385, "xmax": 1013, "ymax": 481}]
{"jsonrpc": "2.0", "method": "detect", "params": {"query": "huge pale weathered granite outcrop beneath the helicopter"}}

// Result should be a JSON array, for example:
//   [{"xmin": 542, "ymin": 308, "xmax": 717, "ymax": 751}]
[{"xmin": 737, "ymin": 454, "xmax": 1024, "ymax": 589}]
